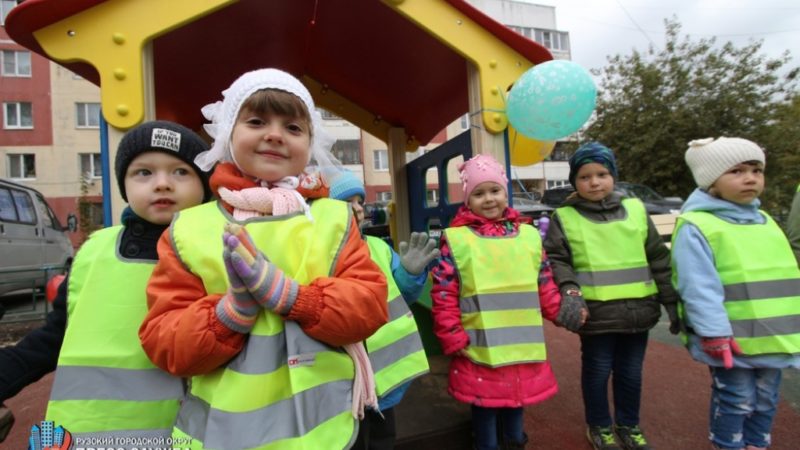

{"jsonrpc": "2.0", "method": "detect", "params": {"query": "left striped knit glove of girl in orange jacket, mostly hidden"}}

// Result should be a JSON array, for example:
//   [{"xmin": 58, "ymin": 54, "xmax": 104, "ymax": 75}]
[{"xmin": 217, "ymin": 241, "xmax": 261, "ymax": 333}]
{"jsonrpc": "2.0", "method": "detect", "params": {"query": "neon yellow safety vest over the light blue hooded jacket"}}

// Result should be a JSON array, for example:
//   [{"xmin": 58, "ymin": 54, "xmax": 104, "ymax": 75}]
[{"xmin": 673, "ymin": 211, "xmax": 800, "ymax": 355}]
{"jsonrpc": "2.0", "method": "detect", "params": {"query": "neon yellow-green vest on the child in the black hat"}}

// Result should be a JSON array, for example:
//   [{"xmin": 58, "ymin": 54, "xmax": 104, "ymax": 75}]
[{"xmin": 46, "ymin": 226, "xmax": 184, "ymax": 448}]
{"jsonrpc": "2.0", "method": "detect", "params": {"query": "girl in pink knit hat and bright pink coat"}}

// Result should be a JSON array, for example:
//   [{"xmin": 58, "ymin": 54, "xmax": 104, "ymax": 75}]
[{"xmin": 431, "ymin": 155, "xmax": 580, "ymax": 450}]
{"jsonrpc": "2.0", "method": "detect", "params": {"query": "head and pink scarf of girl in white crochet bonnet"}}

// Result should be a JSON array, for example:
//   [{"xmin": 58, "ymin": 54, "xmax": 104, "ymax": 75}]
[{"xmin": 195, "ymin": 69, "xmax": 341, "ymax": 220}]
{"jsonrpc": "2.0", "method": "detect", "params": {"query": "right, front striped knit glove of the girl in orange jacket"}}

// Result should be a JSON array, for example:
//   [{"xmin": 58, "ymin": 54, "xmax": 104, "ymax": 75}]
[{"xmin": 225, "ymin": 223, "xmax": 299, "ymax": 316}]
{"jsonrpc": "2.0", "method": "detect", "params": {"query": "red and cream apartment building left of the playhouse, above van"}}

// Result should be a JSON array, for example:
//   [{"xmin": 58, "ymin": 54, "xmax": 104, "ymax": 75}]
[{"xmin": 0, "ymin": 0, "xmax": 102, "ymax": 245}]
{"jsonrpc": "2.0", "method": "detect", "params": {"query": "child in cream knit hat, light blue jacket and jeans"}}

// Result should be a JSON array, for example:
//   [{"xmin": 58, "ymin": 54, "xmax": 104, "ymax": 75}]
[{"xmin": 672, "ymin": 137, "xmax": 800, "ymax": 450}]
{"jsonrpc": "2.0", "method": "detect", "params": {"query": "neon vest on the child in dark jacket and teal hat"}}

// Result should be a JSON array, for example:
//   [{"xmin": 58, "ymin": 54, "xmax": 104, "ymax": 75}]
[{"xmin": 556, "ymin": 198, "xmax": 658, "ymax": 301}]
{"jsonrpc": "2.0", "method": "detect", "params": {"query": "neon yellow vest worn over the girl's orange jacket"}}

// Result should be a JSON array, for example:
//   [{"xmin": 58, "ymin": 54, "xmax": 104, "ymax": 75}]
[{"xmin": 170, "ymin": 199, "xmax": 355, "ymax": 449}]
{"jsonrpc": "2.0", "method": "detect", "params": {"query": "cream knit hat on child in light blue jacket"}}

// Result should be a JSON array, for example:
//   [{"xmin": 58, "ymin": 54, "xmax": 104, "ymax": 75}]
[{"xmin": 686, "ymin": 137, "xmax": 766, "ymax": 189}]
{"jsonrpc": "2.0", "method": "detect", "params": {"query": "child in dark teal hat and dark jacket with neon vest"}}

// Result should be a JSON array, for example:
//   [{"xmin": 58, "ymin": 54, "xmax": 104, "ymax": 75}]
[{"xmin": 544, "ymin": 142, "xmax": 678, "ymax": 449}]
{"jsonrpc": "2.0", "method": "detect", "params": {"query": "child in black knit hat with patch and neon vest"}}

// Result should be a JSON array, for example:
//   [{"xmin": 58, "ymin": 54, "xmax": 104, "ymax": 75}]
[{"xmin": 0, "ymin": 121, "xmax": 211, "ymax": 448}]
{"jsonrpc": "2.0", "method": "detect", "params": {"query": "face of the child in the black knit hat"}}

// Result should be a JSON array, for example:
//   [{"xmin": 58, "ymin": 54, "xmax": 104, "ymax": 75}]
[{"xmin": 125, "ymin": 152, "xmax": 203, "ymax": 225}]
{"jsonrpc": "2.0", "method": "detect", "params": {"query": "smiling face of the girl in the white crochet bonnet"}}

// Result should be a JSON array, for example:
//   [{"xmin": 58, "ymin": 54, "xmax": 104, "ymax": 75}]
[{"xmin": 231, "ymin": 108, "xmax": 311, "ymax": 183}]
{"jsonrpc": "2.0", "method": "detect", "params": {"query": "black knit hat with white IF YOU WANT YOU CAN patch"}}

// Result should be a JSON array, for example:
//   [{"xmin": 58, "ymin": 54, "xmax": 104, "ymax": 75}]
[{"xmin": 114, "ymin": 120, "xmax": 211, "ymax": 202}]
